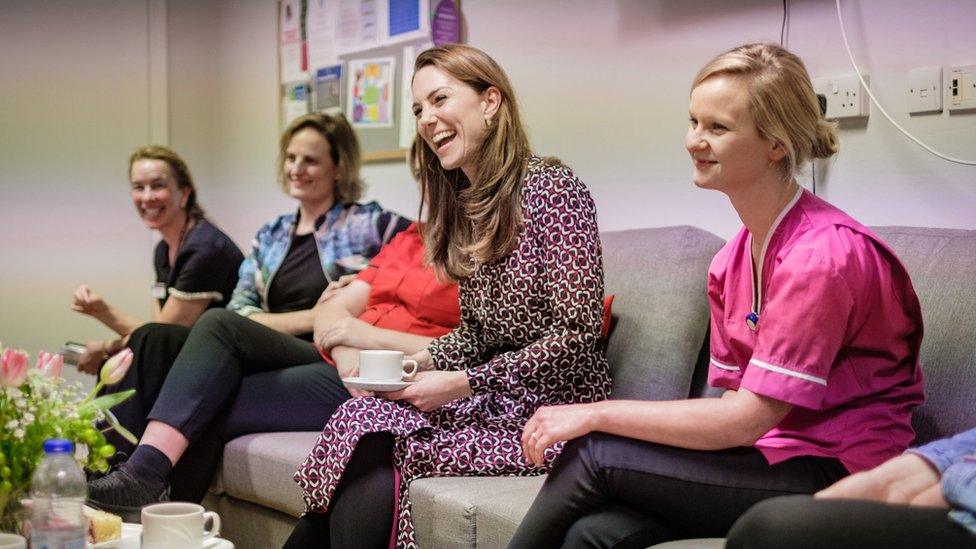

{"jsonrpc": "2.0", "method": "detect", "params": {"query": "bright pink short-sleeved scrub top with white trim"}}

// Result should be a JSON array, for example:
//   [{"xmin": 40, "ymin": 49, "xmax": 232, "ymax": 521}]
[{"xmin": 708, "ymin": 190, "xmax": 924, "ymax": 473}]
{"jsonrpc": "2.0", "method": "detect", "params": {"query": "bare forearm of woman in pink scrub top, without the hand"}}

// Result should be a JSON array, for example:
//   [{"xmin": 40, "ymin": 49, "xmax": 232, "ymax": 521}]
[{"xmin": 590, "ymin": 398, "xmax": 768, "ymax": 450}]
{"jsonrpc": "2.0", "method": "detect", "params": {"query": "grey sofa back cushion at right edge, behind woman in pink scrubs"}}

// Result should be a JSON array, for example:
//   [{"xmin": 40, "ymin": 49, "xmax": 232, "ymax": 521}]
[{"xmin": 872, "ymin": 227, "xmax": 976, "ymax": 445}]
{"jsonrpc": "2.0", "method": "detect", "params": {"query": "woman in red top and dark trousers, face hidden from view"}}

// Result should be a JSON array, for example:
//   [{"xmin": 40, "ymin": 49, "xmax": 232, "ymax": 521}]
[{"xmin": 117, "ymin": 219, "xmax": 461, "ymax": 501}]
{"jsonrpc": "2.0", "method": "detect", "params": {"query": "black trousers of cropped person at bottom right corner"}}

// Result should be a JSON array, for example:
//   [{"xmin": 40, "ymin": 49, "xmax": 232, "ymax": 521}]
[{"xmin": 726, "ymin": 496, "xmax": 976, "ymax": 549}]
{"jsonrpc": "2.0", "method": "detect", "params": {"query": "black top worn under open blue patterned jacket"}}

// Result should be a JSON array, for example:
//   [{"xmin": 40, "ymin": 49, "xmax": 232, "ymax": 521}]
[{"xmin": 268, "ymin": 233, "xmax": 329, "ymax": 313}]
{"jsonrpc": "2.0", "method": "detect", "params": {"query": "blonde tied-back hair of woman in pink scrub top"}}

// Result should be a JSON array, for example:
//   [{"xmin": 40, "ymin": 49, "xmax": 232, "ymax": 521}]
[{"xmin": 691, "ymin": 44, "xmax": 839, "ymax": 181}]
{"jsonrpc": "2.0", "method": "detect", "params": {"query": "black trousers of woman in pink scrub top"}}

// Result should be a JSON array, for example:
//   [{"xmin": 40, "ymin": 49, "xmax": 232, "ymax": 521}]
[{"xmin": 510, "ymin": 433, "xmax": 847, "ymax": 548}]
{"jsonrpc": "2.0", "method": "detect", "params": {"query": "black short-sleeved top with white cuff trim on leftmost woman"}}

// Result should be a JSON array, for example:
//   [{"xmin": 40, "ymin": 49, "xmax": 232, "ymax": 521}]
[{"xmin": 153, "ymin": 218, "xmax": 244, "ymax": 308}]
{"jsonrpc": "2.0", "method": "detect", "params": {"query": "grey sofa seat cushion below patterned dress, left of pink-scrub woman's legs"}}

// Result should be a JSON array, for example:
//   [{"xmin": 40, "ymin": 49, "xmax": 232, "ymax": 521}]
[{"xmin": 410, "ymin": 476, "xmax": 545, "ymax": 548}]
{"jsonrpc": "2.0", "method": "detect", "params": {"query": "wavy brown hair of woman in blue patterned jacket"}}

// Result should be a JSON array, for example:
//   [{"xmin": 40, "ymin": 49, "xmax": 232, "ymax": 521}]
[{"xmin": 278, "ymin": 113, "xmax": 365, "ymax": 204}]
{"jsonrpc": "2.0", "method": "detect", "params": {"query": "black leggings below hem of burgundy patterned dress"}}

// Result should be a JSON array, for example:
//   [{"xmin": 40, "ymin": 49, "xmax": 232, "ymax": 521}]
[{"xmin": 284, "ymin": 433, "xmax": 395, "ymax": 549}]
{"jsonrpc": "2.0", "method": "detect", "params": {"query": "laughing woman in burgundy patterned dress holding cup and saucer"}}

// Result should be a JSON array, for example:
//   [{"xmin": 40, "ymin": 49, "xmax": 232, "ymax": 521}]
[{"xmin": 286, "ymin": 45, "xmax": 610, "ymax": 547}]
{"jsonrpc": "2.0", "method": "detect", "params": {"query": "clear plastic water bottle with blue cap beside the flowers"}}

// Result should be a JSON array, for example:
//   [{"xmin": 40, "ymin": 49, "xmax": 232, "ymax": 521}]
[{"xmin": 31, "ymin": 438, "xmax": 88, "ymax": 549}]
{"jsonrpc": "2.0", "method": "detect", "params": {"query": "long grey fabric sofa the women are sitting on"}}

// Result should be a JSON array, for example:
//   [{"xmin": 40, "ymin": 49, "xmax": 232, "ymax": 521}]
[{"xmin": 204, "ymin": 227, "xmax": 976, "ymax": 549}]
